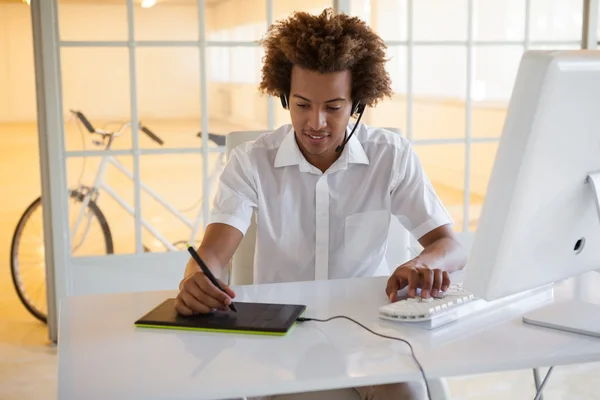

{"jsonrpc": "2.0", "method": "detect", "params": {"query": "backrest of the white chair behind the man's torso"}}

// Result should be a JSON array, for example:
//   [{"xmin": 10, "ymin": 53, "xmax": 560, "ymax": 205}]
[{"xmin": 226, "ymin": 128, "xmax": 412, "ymax": 285}]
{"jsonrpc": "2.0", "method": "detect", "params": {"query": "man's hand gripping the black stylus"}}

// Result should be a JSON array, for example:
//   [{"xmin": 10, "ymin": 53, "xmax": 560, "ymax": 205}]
[{"xmin": 175, "ymin": 271, "xmax": 235, "ymax": 316}]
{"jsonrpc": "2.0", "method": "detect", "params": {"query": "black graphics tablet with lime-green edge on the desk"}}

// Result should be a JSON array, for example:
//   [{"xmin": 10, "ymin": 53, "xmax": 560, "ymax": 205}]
[{"xmin": 135, "ymin": 298, "xmax": 306, "ymax": 336}]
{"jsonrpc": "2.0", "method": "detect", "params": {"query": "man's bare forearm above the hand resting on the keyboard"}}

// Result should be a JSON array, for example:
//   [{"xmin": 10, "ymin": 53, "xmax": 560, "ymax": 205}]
[{"xmin": 415, "ymin": 237, "xmax": 467, "ymax": 273}]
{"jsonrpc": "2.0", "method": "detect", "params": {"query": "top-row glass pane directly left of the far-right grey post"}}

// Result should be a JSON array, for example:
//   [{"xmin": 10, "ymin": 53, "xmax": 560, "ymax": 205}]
[{"xmin": 529, "ymin": 0, "xmax": 583, "ymax": 41}]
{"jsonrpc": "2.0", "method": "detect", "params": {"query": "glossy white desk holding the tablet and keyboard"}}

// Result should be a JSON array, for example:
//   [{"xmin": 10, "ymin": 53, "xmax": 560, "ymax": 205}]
[{"xmin": 58, "ymin": 273, "xmax": 600, "ymax": 400}]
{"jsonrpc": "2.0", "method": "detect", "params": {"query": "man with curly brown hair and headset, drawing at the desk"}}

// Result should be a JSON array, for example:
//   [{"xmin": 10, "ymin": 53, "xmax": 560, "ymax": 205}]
[{"xmin": 177, "ymin": 10, "xmax": 466, "ymax": 399}]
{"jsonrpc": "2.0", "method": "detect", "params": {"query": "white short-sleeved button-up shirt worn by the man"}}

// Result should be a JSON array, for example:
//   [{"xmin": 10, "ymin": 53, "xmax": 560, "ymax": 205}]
[{"xmin": 209, "ymin": 124, "xmax": 453, "ymax": 283}]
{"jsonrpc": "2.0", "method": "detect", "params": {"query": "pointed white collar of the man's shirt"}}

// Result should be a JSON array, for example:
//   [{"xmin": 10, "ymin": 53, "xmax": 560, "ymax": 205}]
[{"xmin": 274, "ymin": 127, "xmax": 369, "ymax": 171}]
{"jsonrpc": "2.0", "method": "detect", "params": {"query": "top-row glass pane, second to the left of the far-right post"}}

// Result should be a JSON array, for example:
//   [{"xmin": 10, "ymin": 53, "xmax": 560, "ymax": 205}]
[{"xmin": 473, "ymin": 0, "xmax": 525, "ymax": 40}]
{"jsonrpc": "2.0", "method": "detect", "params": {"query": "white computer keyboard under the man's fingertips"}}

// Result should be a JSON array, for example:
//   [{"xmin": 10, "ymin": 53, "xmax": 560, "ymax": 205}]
[{"xmin": 379, "ymin": 285, "xmax": 476, "ymax": 322}]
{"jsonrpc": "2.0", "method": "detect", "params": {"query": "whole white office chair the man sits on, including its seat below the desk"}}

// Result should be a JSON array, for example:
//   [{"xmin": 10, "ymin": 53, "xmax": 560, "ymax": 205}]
[{"xmin": 226, "ymin": 129, "xmax": 450, "ymax": 400}]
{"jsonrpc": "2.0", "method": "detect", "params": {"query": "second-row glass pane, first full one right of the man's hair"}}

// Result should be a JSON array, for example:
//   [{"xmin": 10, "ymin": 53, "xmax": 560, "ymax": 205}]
[{"xmin": 413, "ymin": 46, "xmax": 466, "ymax": 139}]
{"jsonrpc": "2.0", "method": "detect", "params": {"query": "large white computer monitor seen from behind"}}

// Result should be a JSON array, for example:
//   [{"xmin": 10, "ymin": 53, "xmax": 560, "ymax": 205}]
[{"xmin": 463, "ymin": 50, "xmax": 600, "ymax": 336}]
